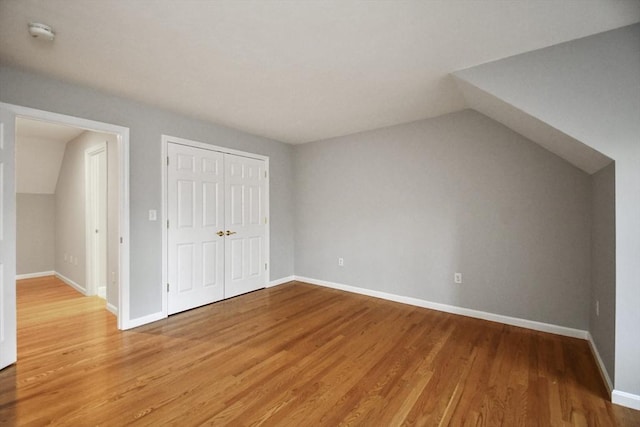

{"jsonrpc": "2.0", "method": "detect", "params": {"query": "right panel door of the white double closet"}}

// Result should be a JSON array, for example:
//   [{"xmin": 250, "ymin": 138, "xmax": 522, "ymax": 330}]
[{"xmin": 224, "ymin": 154, "xmax": 267, "ymax": 298}]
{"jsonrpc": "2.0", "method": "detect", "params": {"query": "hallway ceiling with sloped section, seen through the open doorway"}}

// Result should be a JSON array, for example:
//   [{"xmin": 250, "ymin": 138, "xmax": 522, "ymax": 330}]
[{"xmin": 16, "ymin": 118, "xmax": 84, "ymax": 194}]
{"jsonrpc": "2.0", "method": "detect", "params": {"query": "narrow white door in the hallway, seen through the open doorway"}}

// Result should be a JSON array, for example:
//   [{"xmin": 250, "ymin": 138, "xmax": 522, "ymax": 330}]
[{"xmin": 85, "ymin": 144, "xmax": 108, "ymax": 298}]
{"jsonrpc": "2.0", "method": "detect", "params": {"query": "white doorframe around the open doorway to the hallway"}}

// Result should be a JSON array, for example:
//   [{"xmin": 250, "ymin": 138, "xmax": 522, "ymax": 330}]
[{"xmin": 0, "ymin": 102, "xmax": 136, "ymax": 329}]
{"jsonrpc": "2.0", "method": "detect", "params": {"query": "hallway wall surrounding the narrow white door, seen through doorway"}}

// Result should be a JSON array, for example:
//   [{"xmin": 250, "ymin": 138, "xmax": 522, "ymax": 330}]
[{"xmin": 55, "ymin": 131, "xmax": 119, "ymax": 307}]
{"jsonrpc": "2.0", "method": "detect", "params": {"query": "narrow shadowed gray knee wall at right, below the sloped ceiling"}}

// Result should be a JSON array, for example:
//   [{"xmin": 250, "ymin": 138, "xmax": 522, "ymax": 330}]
[{"xmin": 589, "ymin": 163, "xmax": 616, "ymax": 378}]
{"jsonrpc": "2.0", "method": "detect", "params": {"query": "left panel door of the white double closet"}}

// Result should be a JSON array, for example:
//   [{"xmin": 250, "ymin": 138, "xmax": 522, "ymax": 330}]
[{"xmin": 167, "ymin": 143, "xmax": 224, "ymax": 314}]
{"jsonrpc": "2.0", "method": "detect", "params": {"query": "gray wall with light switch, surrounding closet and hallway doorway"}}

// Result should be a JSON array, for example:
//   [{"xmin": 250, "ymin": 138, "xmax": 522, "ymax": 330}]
[{"xmin": 0, "ymin": 66, "xmax": 293, "ymax": 318}]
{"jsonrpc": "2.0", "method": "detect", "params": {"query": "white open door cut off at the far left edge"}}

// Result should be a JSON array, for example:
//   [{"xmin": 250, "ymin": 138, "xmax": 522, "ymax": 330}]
[{"xmin": 0, "ymin": 108, "xmax": 17, "ymax": 369}]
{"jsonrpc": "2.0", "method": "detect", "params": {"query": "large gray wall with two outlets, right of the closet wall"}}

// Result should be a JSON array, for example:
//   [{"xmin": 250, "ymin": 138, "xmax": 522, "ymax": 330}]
[{"xmin": 295, "ymin": 110, "xmax": 591, "ymax": 329}]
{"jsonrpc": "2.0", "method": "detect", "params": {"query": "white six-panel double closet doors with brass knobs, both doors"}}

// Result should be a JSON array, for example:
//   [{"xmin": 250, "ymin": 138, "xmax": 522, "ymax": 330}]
[{"xmin": 167, "ymin": 143, "xmax": 267, "ymax": 314}]
